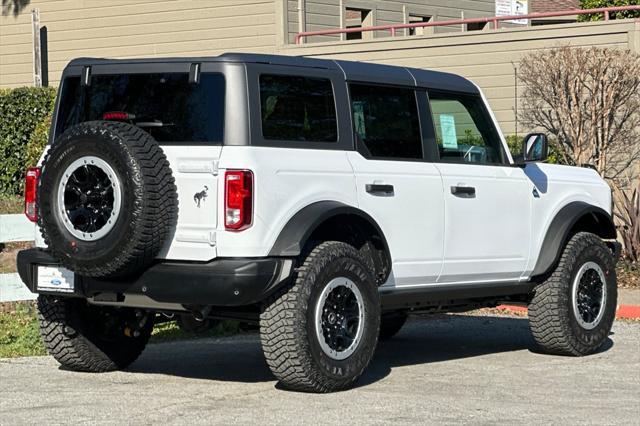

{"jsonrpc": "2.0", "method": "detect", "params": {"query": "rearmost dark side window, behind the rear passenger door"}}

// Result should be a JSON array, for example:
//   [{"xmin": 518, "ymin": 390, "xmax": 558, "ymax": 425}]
[{"xmin": 260, "ymin": 74, "xmax": 338, "ymax": 142}]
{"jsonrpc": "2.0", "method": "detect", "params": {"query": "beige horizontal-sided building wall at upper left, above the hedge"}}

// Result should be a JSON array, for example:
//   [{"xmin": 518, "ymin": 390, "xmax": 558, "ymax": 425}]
[{"xmin": 0, "ymin": 0, "xmax": 277, "ymax": 87}]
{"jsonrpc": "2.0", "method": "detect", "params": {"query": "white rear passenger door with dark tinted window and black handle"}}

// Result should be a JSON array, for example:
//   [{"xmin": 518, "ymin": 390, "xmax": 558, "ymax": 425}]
[{"xmin": 348, "ymin": 83, "xmax": 444, "ymax": 288}]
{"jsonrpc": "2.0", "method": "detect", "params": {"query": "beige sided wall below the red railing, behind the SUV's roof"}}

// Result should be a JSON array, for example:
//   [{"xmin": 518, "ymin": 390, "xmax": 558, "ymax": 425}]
[{"xmin": 278, "ymin": 20, "xmax": 640, "ymax": 134}]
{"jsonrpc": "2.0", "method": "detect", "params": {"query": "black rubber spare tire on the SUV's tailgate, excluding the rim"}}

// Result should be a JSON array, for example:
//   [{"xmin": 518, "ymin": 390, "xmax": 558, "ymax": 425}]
[{"xmin": 37, "ymin": 121, "xmax": 178, "ymax": 277}]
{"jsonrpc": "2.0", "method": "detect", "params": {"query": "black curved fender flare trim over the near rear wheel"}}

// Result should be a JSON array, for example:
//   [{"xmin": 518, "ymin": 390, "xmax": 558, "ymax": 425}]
[{"xmin": 269, "ymin": 201, "xmax": 390, "ymax": 257}]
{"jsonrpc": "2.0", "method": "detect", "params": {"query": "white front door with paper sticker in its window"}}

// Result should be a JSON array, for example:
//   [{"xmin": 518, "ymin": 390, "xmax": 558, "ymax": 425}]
[{"xmin": 429, "ymin": 91, "xmax": 532, "ymax": 283}]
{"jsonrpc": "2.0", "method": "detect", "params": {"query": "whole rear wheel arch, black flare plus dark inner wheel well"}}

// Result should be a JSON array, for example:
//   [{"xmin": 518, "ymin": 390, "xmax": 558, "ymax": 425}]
[{"xmin": 269, "ymin": 201, "xmax": 391, "ymax": 285}]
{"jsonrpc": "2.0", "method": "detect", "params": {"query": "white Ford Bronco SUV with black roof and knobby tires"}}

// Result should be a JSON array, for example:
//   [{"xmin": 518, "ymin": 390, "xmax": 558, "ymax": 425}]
[{"xmin": 18, "ymin": 54, "xmax": 619, "ymax": 392}]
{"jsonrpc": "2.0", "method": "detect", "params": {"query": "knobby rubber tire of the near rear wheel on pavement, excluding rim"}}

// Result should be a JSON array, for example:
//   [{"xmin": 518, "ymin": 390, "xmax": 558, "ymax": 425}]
[{"xmin": 260, "ymin": 241, "xmax": 380, "ymax": 393}]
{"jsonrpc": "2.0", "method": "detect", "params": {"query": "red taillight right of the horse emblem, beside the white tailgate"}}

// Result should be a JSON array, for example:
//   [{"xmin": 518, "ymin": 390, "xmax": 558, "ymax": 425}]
[{"xmin": 224, "ymin": 170, "xmax": 253, "ymax": 231}]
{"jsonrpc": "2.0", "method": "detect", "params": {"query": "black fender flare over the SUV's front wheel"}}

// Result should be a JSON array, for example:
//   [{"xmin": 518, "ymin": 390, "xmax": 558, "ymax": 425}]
[{"xmin": 532, "ymin": 201, "xmax": 616, "ymax": 276}]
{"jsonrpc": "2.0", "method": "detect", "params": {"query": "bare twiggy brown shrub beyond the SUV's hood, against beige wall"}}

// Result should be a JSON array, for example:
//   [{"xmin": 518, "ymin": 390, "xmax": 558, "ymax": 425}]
[{"xmin": 518, "ymin": 46, "xmax": 640, "ymax": 186}]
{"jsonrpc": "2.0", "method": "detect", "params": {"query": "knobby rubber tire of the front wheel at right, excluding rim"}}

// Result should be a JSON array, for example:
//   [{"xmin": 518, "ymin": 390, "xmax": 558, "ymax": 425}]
[{"xmin": 529, "ymin": 232, "xmax": 617, "ymax": 356}]
